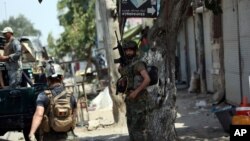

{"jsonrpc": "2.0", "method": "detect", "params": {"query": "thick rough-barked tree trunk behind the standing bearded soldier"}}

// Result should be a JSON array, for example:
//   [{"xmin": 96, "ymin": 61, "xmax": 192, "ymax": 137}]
[{"xmin": 147, "ymin": 0, "xmax": 191, "ymax": 141}]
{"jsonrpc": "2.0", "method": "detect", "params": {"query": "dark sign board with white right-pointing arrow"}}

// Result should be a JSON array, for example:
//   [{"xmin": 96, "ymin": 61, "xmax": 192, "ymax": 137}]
[{"xmin": 121, "ymin": 0, "xmax": 157, "ymax": 18}]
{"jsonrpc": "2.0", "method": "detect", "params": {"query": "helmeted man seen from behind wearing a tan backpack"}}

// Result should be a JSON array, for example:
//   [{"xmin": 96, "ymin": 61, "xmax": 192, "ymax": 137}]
[{"xmin": 29, "ymin": 62, "xmax": 76, "ymax": 141}]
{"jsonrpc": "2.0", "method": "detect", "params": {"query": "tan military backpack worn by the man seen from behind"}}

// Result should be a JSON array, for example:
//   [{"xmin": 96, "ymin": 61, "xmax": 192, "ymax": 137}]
[{"xmin": 42, "ymin": 90, "xmax": 75, "ymax": 132}]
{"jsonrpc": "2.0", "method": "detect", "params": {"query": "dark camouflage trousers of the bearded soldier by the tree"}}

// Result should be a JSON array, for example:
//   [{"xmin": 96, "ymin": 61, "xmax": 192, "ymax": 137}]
[{"xmin": 126, "ymin": 93, "xmax": 152, "ymax": 141}]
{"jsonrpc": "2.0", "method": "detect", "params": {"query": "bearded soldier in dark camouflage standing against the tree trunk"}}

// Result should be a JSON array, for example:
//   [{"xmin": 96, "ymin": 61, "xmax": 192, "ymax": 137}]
[{"xmin": 119, "ymin": 41, "xmax": 150, "ymax": 141}]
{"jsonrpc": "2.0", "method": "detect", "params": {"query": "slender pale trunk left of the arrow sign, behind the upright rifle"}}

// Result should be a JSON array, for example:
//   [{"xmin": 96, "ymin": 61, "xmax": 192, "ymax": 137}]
[{"xmin": 97, "ymin": 0, "xmax": 125, "ymax": 124}]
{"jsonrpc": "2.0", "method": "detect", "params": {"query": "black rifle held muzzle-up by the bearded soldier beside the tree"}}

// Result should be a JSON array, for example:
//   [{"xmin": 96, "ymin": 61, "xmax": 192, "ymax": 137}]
[{"xmin": 113, "ymin": 31, "xmax": 128, "ymax": 66}]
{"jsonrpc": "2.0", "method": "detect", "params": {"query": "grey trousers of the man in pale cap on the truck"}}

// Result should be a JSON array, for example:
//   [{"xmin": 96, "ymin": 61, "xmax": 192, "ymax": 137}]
[{"xmin": 8, "ymin": 70, "xmax": 22, "ymax": 88}]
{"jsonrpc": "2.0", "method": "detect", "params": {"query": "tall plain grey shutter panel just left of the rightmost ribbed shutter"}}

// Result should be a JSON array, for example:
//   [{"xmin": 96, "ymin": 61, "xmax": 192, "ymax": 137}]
[{"xmin": 222, "ymin": 0, "xmax": 241, "ymax": 104}]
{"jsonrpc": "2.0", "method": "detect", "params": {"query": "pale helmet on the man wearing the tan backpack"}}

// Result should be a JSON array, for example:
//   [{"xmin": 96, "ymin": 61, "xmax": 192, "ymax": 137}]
[{"xmin": 45, "ymin": 63, "xmax": 64, "ymax": 78}]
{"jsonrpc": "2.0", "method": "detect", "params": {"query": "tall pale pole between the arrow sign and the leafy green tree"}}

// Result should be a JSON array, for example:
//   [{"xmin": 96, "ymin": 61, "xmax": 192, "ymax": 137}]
[{"xmin": 96, "ymin": 0, "xmax": 125, "ymax": 124}]
